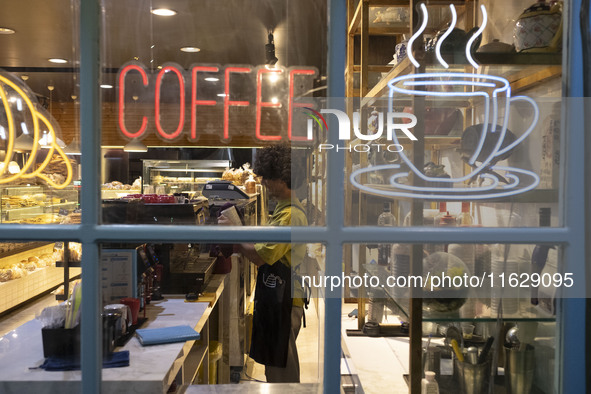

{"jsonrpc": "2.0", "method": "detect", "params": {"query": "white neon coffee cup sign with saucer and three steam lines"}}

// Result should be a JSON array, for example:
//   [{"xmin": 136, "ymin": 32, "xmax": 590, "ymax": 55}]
[{"xmin": 350, "ymin": 4, "xmax": 539, "ymax": 200}]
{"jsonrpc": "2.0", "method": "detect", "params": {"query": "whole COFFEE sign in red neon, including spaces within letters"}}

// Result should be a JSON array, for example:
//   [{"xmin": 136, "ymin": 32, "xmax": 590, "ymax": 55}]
[{"xmin": 117, "ymin": 62, "xmax": 318, "ymax": 142}]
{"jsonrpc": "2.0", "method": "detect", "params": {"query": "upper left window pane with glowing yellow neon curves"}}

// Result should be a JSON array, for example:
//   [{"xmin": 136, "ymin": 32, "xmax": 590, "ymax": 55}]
[{"xmin": 0, "ymin": 0, "xmax": 80, "ymax": 224}]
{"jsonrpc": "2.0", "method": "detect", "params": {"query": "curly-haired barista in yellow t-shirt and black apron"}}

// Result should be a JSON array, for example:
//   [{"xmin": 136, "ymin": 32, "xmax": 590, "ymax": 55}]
[{"xmin": 218, "ymin": 145, "xmax": 308, "ymax": 383}]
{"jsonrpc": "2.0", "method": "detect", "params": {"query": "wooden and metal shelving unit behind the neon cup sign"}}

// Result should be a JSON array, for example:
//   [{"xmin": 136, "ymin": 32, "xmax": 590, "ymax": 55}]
[{"xmin": 344, "ymin": 0, "xmax": 562, "ymax": 393}]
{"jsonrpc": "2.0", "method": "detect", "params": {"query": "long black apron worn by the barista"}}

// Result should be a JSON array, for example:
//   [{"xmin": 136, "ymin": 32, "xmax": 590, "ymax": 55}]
[{"xmin": 250, "ymin": 261, "xmax": 293, "ymax": 368}]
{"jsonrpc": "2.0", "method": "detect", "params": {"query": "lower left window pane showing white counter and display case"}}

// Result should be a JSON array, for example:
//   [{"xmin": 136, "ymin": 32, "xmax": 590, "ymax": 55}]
[{"xmin": 0, "ymin": 241, "xmax": 82, "ymax": 391}]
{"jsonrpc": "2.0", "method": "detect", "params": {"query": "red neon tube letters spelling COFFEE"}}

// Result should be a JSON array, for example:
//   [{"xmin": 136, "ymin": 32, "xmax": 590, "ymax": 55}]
[{"xmin": 117, "ymin": 62, "xmax": 317, "ymax": 141}]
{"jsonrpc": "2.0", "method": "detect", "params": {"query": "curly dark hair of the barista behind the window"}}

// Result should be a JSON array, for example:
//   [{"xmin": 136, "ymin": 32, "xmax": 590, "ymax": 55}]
[{"xmin": 253, "ymin": 144, "xmax": 305, "ymax": 189}]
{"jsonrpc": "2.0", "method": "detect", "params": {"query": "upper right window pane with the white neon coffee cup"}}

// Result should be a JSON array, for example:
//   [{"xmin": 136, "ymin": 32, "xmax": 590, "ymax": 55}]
[{"xmin": 343, "ymin": 1, "xmax": 566, "ymax": 227}]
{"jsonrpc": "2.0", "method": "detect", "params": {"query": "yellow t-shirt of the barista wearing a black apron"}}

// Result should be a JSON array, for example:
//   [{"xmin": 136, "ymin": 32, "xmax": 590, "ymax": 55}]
[{"xmin": 254, "ymin": 199, "xmax": 308, "ymax": 306}]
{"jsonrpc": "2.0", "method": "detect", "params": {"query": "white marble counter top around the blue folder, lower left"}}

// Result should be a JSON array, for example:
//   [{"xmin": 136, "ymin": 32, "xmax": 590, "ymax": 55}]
[{"xmin": 0, "ymin": 275, "xmax": 224, "ymax": 394}]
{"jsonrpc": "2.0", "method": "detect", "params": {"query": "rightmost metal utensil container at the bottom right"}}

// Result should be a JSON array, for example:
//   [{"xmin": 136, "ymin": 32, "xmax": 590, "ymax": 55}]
[{"xmin": 505, "ymin": 345, "xmax": 536, "ymax": 394}]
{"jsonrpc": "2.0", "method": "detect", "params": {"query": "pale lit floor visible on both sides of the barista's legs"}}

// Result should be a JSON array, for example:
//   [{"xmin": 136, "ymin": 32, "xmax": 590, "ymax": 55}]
[{"xmin": 240, "ymin": 302, "xmax": 322, "ymax": 383}]
